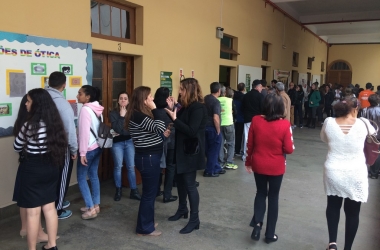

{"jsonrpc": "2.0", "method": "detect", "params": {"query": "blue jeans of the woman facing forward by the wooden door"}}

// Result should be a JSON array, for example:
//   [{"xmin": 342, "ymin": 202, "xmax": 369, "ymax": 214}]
[{"xmin": 111, "ymin": 139, "xmax": 137, "ymax": 189}]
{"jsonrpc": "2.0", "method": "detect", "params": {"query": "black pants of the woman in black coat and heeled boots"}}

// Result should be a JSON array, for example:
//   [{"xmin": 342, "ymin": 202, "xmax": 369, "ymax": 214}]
[{"xmin": 176, "ymin": 171, "xmax": 199, "ymax": 213}]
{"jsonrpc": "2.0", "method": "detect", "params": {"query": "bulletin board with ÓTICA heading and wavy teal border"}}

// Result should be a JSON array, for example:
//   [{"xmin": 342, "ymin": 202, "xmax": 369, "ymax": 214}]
[{"xmin": 0, "ymin": 31, "xmax": 92, "ymax": 137}]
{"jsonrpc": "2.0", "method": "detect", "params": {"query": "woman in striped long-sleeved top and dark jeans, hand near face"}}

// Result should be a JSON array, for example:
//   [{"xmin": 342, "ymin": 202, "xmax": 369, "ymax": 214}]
[{"xmin": 125, "ymin": 86, "xmax": 170, "ymax": 236}]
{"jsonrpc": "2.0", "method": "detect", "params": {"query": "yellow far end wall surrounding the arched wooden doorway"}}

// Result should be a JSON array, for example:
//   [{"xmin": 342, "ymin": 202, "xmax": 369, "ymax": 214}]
[{"xmin": 329, "ymin": 44, "xmax": 380, "ymax": 89}]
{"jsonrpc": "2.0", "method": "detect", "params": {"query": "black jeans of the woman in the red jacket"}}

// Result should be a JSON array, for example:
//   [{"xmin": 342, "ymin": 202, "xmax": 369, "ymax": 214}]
[{"xmin": 253, "ymin": 173, "xmax": 283, "ymax": 238}]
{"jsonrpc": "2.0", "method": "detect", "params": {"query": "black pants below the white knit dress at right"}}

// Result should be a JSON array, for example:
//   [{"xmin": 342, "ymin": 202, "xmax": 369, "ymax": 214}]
[{"xmin": 326, "ymin": 195, "xmax": 361, "ymax": 250}]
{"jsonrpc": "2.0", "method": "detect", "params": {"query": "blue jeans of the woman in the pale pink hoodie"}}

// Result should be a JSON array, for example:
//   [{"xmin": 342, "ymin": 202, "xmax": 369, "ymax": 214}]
[{"xmin": 77, "ymin": 148, "xmax": 102, "ymax": 208}]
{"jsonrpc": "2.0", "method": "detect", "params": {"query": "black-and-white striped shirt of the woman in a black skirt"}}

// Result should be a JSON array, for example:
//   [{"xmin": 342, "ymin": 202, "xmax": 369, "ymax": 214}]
[{"xmin": 13, "ymin": 122, "xmax": 47, "ymax": 154}]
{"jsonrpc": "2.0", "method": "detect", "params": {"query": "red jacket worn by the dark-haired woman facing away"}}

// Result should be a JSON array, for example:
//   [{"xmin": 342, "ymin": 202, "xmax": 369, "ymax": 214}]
[{"xmin": 245, "ymin": 115, "xmax": 294, "ymax": 175}]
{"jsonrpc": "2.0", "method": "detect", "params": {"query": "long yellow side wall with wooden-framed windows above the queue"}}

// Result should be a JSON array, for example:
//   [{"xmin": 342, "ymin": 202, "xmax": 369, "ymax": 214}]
[{"xmin": 0, "ymin": 0, "xmax": 327, "ymax": 208}]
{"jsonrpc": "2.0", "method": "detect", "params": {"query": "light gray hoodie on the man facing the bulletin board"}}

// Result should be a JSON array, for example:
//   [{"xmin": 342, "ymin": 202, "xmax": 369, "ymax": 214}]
[{"xmin": 46, "ymin": 87, "xmax": 78, "ymax": 155}]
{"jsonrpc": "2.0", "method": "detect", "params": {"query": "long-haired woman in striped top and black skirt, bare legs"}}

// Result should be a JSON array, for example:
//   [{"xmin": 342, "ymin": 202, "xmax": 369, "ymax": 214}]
[{"xmin": 14, "ymin": 89, "xmax": 68, "ymax": 250}]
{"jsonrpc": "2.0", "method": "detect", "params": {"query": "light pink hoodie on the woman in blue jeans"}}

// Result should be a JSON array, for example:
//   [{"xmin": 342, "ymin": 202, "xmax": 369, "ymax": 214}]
[{"xmin": 78, "ymin": 101, "xmax": 104, "ymax": 156}]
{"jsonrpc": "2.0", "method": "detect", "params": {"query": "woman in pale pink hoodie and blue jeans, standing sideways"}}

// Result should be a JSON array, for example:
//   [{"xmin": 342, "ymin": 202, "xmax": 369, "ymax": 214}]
[{"xmin": 77, "ymin": 85, "xmax": 104, "ymax": 220}]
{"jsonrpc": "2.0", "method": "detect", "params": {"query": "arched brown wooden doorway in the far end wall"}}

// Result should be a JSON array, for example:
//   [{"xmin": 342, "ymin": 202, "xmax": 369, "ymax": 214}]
[{"xmin": 327, "ymin": 60, "xmax": 352, "ymax": 88}]
